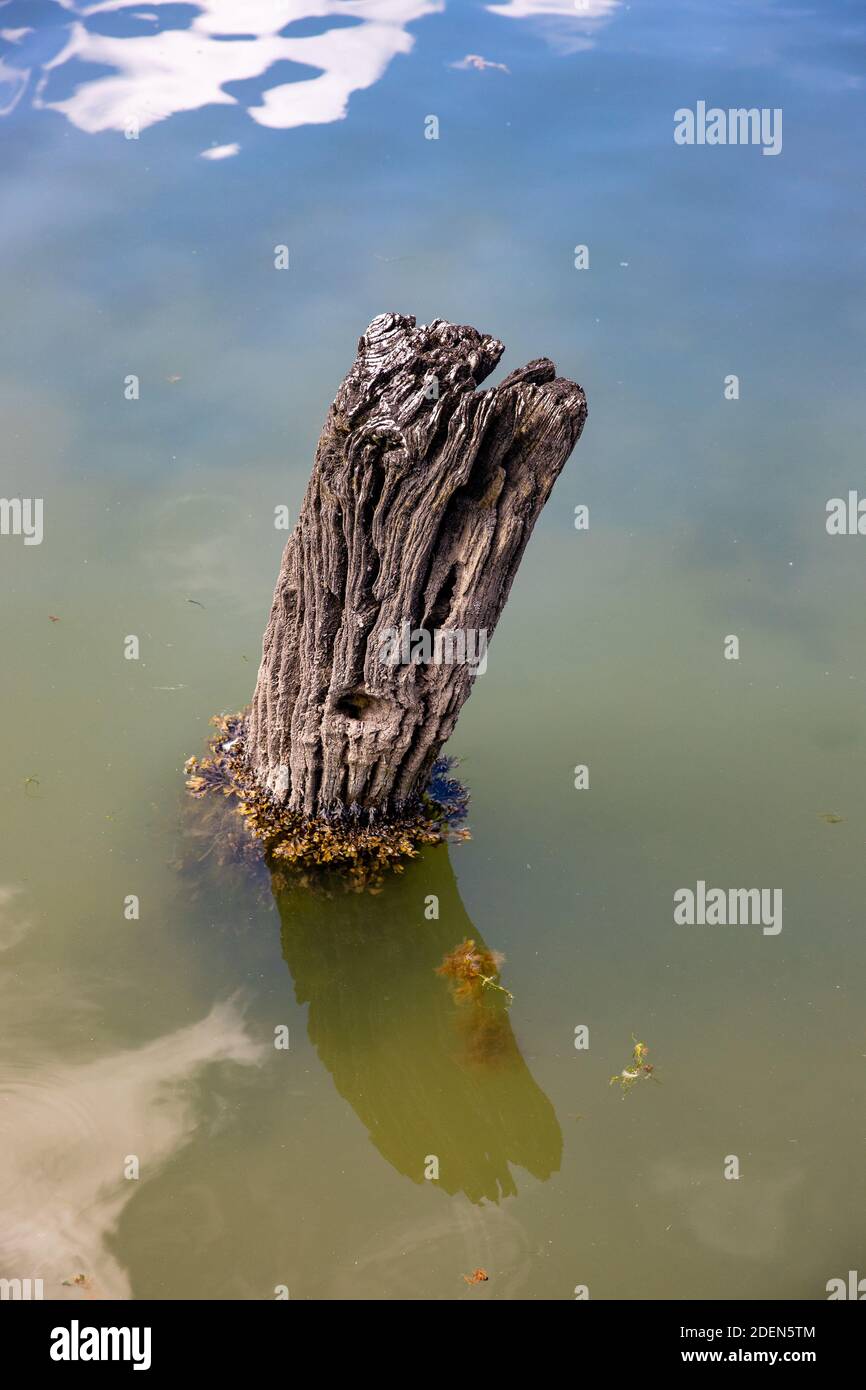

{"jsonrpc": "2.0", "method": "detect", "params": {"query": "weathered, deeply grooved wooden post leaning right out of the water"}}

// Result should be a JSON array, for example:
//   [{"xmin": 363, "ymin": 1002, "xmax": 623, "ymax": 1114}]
[{"xmin": 246, "ymin": 314, "xmax": 587, "ymax": 816}]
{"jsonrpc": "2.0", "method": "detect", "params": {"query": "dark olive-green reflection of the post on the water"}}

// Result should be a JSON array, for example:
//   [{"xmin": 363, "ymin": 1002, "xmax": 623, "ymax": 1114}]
[{"xmin": 274, "ymin": 845, "xmax": 562, "ymax": 1202}]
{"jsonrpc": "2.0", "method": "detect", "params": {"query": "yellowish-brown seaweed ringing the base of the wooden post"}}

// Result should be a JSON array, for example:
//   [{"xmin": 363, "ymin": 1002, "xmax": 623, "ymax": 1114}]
[{"xmin": 183, "ymin": 713, "xmax": 468, "ymax": 892}]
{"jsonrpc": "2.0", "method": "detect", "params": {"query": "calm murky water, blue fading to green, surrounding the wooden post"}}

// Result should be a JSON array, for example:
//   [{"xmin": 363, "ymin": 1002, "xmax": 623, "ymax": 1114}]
[{"xmin": 0, "ymin": 0, "xmax": 866, "ymax": 1300}]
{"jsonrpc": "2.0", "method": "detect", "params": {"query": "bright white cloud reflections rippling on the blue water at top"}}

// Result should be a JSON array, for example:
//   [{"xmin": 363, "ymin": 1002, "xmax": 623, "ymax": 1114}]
[{"xmin": 0, "ymin": 0, "xmax": 619, "ymax": 142}]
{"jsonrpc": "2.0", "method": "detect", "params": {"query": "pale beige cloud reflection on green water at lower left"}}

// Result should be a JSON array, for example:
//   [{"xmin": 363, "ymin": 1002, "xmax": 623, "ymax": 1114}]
[{"xmin": 0, "ymin": 1002, "xmax": 261, "ymax": 1298}]
